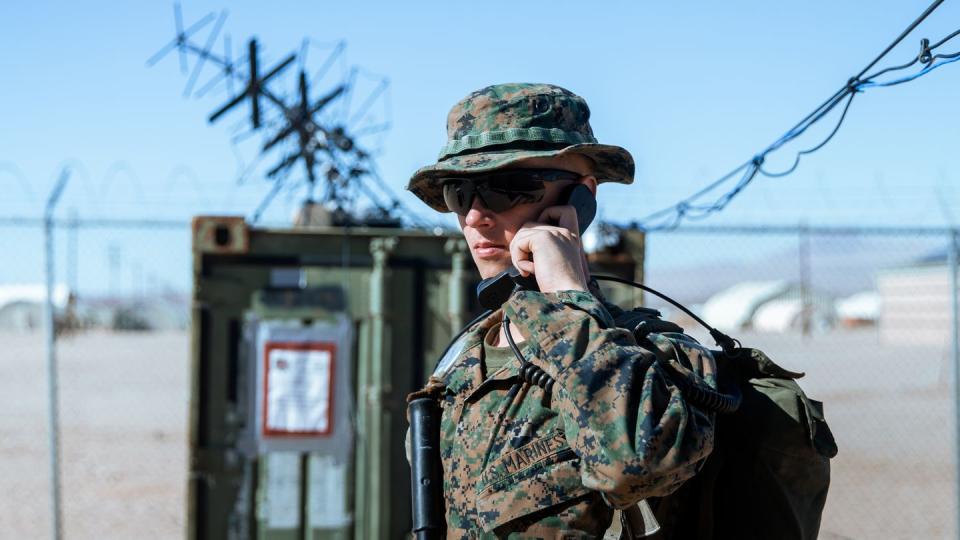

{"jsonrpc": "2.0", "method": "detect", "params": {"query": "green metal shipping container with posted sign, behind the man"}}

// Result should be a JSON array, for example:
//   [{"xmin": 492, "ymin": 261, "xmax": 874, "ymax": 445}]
[{"xmin": 187, "ymin": 217, "xmax": 479, "ymax": 540}]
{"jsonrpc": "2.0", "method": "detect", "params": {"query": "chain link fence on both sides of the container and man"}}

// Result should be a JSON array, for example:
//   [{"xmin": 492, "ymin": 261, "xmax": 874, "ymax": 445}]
[{"xmin": 0, "ymin": 222, "xmax": 958, "ymax": 539}]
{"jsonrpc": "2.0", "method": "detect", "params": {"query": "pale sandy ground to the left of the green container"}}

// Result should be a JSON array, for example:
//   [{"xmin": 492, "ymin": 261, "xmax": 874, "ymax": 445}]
[{"xmin": 0, "ymin": 333, "xmax": 189, "ymax": 540}]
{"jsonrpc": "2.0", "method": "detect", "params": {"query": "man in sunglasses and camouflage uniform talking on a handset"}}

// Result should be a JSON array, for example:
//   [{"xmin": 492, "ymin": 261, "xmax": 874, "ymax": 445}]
[{"xmin": 408, "ymin": 83, "xmax": 716, "ymax": 538}]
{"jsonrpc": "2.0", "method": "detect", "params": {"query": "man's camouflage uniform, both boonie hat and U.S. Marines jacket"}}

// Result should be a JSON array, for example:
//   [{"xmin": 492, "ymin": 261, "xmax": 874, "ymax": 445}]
[{"xmin": 409, "ymin": 84, "xmax": 716, "ymax": 538}]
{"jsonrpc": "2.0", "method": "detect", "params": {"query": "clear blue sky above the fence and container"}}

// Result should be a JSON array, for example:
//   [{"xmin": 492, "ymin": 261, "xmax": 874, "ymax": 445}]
[{"xmin": 0, "ymin": 0, "xmax": 960, "ymax": 291}]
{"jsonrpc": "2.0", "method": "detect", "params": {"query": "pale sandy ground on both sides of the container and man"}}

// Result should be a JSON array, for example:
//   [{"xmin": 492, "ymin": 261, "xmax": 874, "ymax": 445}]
[{"xmin": 0, "ymin": 331, "xmax": 956, "ymax": 540}]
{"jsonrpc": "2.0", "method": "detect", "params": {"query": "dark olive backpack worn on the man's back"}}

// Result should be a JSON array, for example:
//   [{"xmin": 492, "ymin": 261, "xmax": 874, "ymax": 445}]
[{"xmin": 617, "ymin": 308, "xmax": 837, "ymax": 540}]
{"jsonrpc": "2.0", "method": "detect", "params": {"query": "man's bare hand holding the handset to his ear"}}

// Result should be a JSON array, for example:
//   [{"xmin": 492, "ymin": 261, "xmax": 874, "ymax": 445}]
[{"xmin": 510, "ymin": 206, "xmax": 587, "ymax": 292}]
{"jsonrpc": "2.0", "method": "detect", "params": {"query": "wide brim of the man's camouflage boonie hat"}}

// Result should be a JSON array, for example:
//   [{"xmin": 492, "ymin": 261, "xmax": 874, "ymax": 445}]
[{"xmin": 407, "ymin": 143, "xmax": 635, "ymax": 212}]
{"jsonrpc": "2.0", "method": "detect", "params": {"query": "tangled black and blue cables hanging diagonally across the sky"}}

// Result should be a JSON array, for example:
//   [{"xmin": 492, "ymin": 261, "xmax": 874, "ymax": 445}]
[{"xmin": 630, "ymin": 0, "xmax": 960, "ymax": 231}]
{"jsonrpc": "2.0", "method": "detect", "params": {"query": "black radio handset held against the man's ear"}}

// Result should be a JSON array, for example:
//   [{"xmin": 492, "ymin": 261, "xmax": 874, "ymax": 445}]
[{"xmin": 477, "ymin": 184, "xmax": 597, "ymax": 310}]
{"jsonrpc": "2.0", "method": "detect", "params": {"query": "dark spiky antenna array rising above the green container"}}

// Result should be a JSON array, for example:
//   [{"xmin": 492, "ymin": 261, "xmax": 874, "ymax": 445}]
[{"xmin": 147, "ymin": 3, "xmax": 424, "ymax": 225}]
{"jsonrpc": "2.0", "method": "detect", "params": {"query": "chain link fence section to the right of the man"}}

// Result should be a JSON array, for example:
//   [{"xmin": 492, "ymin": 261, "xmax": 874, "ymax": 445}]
[{"xmin": 645, "ymin": 227, "xmax": 958, "ymax": 539}]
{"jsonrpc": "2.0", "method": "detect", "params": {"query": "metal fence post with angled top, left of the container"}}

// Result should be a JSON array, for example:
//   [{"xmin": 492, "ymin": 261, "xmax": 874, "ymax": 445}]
[{"xmin": 43, "ymin": 169, "xmax": 70, "ymax": 540}]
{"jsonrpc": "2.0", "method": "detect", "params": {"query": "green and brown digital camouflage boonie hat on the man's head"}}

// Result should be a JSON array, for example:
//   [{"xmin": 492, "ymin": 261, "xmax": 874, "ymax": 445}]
[{"xmin": 407, "ymin": 83, "xmax": 634, "ymax": 212}]
